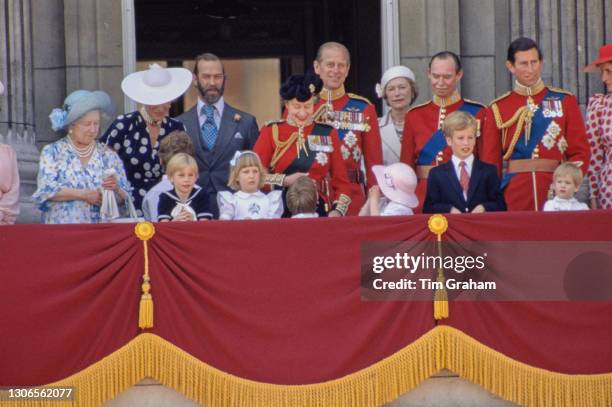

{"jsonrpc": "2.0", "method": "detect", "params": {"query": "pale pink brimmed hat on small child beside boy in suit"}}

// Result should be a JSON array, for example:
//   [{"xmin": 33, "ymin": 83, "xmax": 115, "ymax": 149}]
[{"xmin": 372, "ymin": 163, "xmax": 419, "ymax": 208}]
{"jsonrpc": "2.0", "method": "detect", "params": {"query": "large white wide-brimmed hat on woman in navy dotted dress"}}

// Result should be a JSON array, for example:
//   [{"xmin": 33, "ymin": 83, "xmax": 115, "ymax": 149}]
[{"xmin": 121, "ymin": 64, "xmax": 193, "ymax": 106}]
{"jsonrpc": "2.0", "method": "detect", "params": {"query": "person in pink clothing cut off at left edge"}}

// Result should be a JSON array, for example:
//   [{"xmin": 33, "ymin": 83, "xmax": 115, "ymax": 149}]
[{"xmin": 0, "ymin": 82, "xmax": 19, "ymax": 225}]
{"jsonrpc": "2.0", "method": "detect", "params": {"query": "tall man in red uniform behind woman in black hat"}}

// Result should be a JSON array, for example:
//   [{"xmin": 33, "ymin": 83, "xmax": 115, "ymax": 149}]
[{"xmin": 314, "ymin": 42, "xmax": 382, "ymax": 215}]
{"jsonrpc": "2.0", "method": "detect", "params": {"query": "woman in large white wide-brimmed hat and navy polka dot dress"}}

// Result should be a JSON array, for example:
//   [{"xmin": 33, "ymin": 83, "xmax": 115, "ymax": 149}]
[{"xmin": 102, "ymin": 64, "xmax": 193, "ymax": 216}]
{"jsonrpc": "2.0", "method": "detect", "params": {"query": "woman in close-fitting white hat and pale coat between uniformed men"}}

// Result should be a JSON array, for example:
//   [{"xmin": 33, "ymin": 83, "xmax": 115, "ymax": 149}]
[{"xmin": 376, "ymin": 65, "xmax": 419, "ymax": 165}]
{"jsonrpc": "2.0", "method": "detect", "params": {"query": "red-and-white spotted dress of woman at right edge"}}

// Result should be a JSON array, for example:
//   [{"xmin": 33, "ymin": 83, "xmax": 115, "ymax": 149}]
[{"xmin": 586, "ymin": 94, "xmax": 612, "ymax": 209}]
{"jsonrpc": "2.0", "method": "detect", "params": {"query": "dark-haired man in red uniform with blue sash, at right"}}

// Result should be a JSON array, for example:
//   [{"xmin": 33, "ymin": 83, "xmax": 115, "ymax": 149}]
[{"xmin": 489, "ymin": 37, "xmax": 590, "ymax": 211}]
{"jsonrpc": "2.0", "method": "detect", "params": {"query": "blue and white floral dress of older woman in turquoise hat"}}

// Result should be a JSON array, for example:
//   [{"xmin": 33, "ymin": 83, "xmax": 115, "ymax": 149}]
[{"xmin": 32, "ymin": 137, "xmax": 130, "ymax": 223}]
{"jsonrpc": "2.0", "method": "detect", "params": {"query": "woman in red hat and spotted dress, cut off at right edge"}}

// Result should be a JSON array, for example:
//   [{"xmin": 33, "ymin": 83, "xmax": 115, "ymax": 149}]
[{"xmin": 584, "ymin": 44, "xmax": 612, "ymax": 209}]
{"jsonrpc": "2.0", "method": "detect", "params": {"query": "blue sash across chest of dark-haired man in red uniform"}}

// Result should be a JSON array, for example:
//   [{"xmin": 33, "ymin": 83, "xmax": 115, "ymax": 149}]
[{"xmin": 501, "ymin": 89, "xmax": 565, "ymax": 189}]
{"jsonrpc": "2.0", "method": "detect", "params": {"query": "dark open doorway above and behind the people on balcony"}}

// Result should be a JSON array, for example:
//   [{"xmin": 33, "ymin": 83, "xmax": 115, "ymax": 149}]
[{"xmin": 135, "ymin": 0, "xmax": 381, "ymax": 118}]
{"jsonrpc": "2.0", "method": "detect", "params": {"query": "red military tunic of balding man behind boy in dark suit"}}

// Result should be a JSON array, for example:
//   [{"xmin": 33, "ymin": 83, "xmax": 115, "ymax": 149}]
[{"xmin": 400, "ymin": 92, "xmax": 501, "ymax": 213}]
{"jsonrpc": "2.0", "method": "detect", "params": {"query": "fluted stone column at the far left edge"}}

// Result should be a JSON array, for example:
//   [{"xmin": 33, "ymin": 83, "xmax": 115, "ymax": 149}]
[{"xmin": 0, "ymin": 0, "xmax": 38, "ymax": 222}]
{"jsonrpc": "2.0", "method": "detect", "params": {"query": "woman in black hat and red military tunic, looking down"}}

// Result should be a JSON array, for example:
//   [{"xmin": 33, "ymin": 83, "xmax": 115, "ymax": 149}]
[{"xmin": 253, "ymin": 74, "xmax": 350, "ymax": 216}]
